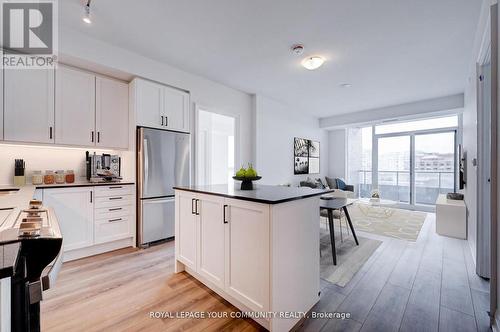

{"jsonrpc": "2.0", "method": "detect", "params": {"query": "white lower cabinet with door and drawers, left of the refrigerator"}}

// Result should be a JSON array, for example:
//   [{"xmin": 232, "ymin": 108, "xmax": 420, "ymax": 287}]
[{"xmin": 42, "ymin": 185, "xmax": 135, "ymax": 261}]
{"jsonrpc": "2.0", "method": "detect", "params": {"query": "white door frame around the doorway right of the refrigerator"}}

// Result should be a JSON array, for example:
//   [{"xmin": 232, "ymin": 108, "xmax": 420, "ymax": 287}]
[{"xmin": 193, "ymin": 103, "xmax": 241, "ymax": 184}]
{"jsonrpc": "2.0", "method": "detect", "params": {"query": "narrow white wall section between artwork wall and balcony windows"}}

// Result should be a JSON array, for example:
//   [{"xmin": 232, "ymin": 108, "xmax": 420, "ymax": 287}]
[{"xmin": 327, "ymin": 129, "xmax": 347, "ymax": 179}]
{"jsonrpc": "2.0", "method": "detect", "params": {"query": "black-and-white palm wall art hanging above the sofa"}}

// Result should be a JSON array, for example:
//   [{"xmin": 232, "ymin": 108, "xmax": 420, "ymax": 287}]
[{"xmin": 293, "ymin": 137, "xmax": 320, "ymax": 174}]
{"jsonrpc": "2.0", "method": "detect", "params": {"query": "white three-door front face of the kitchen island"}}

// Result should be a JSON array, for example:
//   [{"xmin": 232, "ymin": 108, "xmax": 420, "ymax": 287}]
[{"xmin": 176, "ymin": 191, "xmax": 270, "ymax": 311}]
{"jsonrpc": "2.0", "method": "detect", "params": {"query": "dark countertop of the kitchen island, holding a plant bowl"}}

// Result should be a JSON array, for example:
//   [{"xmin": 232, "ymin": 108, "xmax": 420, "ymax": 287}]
[{"xmin": 174, "ymin": 182, "xmax": 333, "ymax": 204}]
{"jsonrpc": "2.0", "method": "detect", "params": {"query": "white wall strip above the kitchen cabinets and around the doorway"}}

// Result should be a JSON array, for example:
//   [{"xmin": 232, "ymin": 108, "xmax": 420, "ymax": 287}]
[{"xmin": 59, "ymin": 27, "xmax": 253, "ymax": 167}]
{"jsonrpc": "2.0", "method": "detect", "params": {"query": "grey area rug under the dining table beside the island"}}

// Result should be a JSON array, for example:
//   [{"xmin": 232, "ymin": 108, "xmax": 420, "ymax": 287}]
[{"xmin": 320, "ymin": 230, "xmax": 382, "ymax": 287}]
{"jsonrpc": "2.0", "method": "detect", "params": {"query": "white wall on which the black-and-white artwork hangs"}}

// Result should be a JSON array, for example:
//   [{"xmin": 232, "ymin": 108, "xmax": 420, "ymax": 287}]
[{"xmin": 254, "ymin": 95, "xmax": 329, "ymax": 185}]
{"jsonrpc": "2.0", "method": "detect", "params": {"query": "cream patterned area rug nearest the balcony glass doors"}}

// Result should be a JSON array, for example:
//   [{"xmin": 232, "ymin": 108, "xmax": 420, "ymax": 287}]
[{"xmin": 348, "ymin": 203, "xmax": 427, "ymax": 241}]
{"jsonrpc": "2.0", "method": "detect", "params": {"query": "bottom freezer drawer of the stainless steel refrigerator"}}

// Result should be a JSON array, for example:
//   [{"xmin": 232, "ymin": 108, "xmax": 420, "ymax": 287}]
[{"xmin": 141, "ymin": 197, "xmax": 175, "ymax": 244}]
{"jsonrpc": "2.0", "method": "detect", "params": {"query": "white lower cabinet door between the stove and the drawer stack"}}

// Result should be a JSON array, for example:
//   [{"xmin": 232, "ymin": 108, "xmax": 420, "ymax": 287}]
[{"xmin": 43, "ymin": 187, "xmax": 94, "ymax": 251}]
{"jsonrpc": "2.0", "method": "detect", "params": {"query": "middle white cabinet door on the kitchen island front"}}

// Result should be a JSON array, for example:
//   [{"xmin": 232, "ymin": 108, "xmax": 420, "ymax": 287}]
[{"xmin": 197, "ymin": 195, "xmax": 225, "ymax": 289}]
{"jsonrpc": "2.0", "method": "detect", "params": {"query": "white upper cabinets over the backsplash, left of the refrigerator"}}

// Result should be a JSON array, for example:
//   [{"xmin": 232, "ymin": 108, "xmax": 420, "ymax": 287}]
[{"xmin": 0, "ymin": 65, "xmax": 130, "ymax": 149}]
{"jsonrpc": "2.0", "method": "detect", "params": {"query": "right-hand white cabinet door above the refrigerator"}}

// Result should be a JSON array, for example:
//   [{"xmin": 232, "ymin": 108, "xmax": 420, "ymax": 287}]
[{"xmin": 163, "ymin": 87, "xmax": 189, "ymax": 132}]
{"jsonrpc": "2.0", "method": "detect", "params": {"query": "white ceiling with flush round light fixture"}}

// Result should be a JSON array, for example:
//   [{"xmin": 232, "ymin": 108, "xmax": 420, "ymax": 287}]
[{"xmin": 59, "ymin": 0, "xmax": 481, "ymax": 117}]
